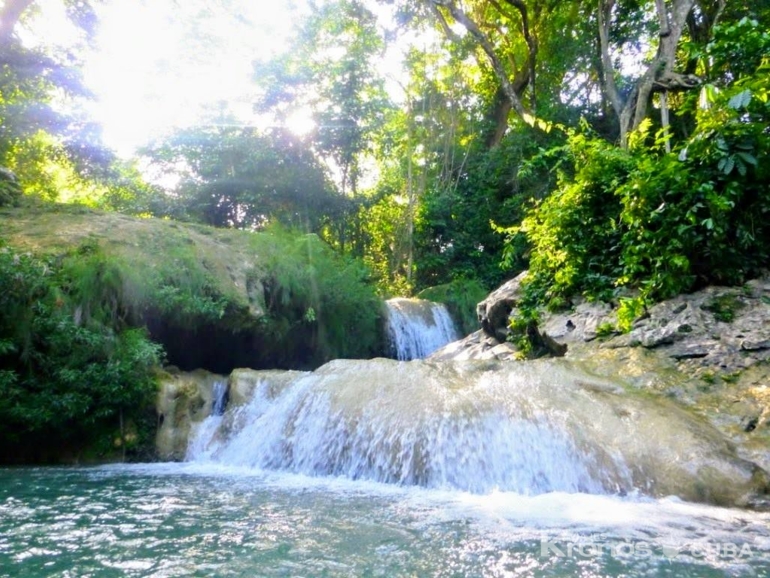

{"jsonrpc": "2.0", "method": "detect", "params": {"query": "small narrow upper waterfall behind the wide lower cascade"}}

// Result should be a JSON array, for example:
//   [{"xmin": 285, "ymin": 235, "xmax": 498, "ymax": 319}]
[{"xmin": 385, "ymin": 298, "xmax": 460, "ymax": 361}]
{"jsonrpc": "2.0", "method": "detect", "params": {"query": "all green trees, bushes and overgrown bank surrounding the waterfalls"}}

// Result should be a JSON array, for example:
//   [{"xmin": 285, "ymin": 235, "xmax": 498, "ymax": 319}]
[{"xmin": 0, "ymin": 0, "xmax": 770, "ymax": 456}]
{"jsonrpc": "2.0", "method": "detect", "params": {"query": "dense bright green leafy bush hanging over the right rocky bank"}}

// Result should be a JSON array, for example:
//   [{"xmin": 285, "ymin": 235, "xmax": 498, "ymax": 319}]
[{"xmin": 501, "ymin": 35, "xmax": 770, "ymax": 308}]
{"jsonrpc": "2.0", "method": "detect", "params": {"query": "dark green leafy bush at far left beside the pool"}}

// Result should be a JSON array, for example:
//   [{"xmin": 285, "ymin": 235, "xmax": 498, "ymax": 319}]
[{"xmin": 0, "ymin": 238, "xmax": 163, "ymax": 458}]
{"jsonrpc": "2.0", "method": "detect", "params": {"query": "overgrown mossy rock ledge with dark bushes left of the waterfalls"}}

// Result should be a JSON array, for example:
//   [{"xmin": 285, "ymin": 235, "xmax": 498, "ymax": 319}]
[{"xmin": 0, "ymin": 205, "xmax": 381, "ymax": 460}]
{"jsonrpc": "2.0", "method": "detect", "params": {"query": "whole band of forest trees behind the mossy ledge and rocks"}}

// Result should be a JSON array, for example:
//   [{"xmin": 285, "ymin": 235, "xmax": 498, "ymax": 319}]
[{"xmin": 0, "ymin": 0, "xmax": 770, "ymax": 302}]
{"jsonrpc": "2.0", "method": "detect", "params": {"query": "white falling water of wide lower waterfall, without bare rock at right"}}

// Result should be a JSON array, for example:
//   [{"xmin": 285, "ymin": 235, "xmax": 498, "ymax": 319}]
[{"xmin": 187, "ymin": 359, "xmax": 633, "ymax": 494}]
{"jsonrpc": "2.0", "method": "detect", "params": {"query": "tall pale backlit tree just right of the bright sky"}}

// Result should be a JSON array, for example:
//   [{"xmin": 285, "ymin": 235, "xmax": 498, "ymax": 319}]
[{"xmin": 255, "ymin": 0, "xmax": 390, "ymax": 256}]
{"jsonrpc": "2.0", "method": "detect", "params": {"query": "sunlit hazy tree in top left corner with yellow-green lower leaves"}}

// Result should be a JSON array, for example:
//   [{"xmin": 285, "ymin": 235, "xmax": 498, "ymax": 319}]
[{"xmin": 0, "ymin": 0, "xmax": 115, "ymax": 199}]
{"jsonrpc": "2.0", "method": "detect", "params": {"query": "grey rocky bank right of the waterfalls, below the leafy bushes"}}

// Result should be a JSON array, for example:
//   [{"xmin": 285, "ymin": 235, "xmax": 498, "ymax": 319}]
[{"xmin": 432, "ymin": 273, "xmax": 770, "ymax": 480}]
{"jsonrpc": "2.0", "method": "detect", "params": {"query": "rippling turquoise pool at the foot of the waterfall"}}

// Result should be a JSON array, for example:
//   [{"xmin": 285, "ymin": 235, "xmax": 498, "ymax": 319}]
[{"xmin": 0, "ymin": 464, "xmax": 770, "ymax": 577}]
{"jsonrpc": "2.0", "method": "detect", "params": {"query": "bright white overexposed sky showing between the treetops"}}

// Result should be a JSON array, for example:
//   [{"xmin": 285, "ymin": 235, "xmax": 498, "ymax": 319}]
[{"xmin": 22, "ymin": 0, "xmax": 412, "ymax": 157}]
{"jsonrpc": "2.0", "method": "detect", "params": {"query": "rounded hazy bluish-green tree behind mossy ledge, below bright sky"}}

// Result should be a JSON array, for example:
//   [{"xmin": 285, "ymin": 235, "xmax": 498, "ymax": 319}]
[{"xmin": 144, "ymin": 125, "xmax": 340, "ymax": 232}]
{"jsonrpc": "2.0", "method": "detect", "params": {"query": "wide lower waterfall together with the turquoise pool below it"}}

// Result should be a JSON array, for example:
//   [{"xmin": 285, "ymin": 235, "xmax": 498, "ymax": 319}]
[{"xmin": 15, "ymin": 359, "xmax": 770, "ymax": 578}]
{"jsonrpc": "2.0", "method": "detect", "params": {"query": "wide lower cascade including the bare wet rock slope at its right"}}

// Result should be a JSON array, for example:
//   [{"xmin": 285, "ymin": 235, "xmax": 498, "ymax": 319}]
[{"xmin": 187, "ymin": 359, "xmax": 753, "ymax": 501}]
